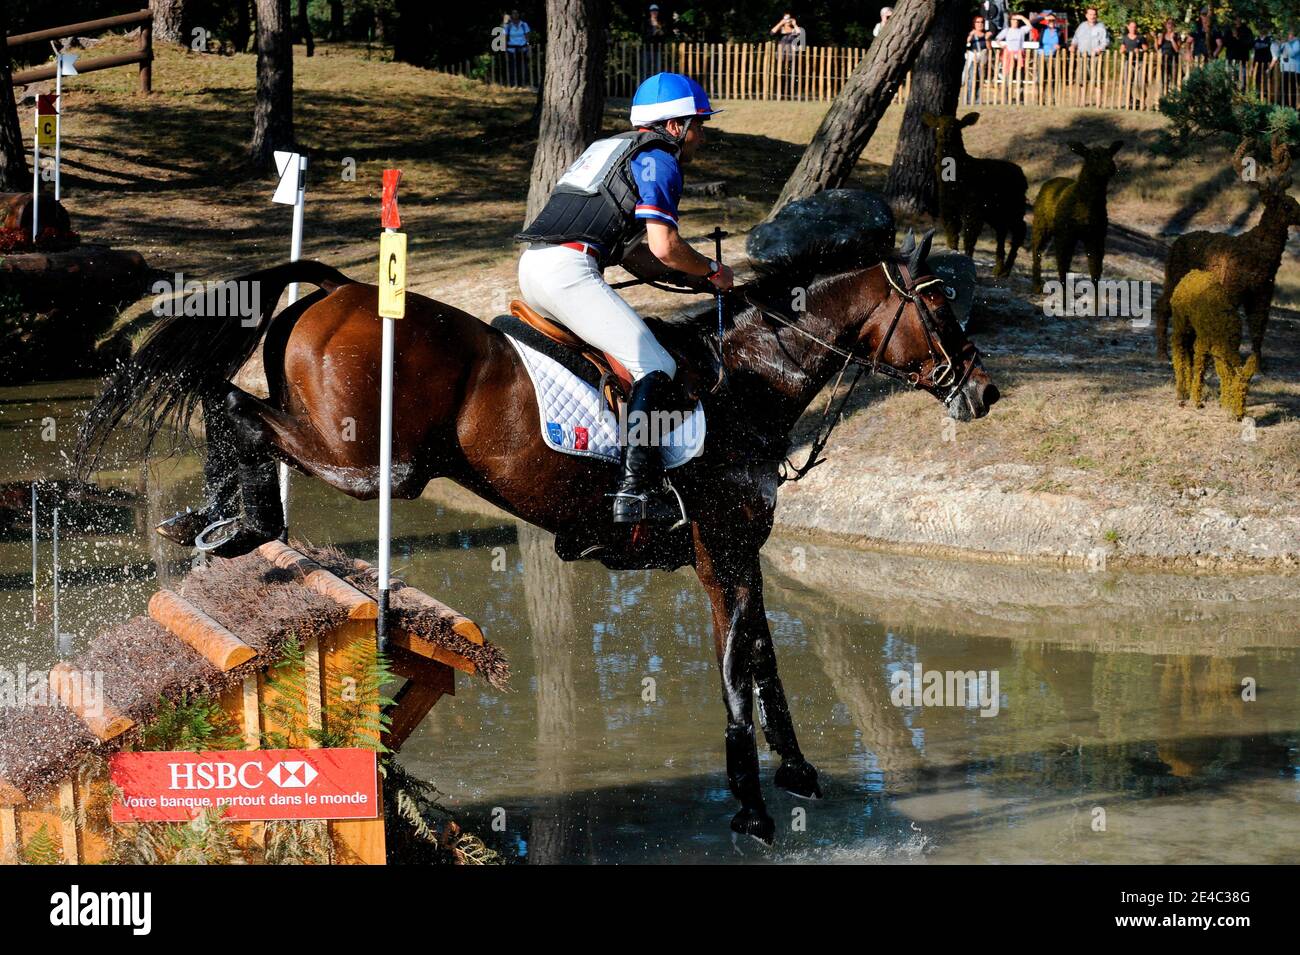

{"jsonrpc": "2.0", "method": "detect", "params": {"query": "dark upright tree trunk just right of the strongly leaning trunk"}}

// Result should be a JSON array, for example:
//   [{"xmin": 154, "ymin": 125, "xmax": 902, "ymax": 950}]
[{"xmin": 885, "ymin": 3, "xmax": 971, "ymax": 214}]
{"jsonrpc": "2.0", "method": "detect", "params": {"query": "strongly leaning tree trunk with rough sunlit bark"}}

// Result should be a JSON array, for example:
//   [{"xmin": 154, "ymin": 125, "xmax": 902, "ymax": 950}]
[{"xmin": 768, "ymin": 0, "xmax": 939, "ymax": 217}]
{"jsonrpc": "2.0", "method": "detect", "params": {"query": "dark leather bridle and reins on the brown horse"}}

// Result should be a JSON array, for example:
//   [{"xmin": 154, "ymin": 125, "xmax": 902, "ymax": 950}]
[{"xmin": 746, "ymin": 261, "xmax": 980, "ymax": 482}]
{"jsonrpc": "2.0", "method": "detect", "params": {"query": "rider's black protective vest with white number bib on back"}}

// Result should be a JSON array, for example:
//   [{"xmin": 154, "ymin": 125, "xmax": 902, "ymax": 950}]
[{"xmin": 515, "ymin": 130, "xmax": 679, "ymax": 266}]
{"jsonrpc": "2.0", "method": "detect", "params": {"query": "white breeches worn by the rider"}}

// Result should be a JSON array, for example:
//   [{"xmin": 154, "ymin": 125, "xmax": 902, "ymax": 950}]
[{"xmin": 519, "ymin": 246, "xmax": 677, "ymax": 381}]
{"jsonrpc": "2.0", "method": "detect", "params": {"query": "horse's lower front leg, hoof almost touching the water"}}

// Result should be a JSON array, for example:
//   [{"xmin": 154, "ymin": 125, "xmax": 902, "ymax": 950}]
[{"xmin": 696, "ymin": 525, "xmax": 776, "ymax": 845}]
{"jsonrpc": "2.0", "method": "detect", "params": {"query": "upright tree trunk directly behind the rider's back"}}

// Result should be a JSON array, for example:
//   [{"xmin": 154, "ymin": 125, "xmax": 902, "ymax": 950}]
[{"xmin": 524, "ymin": 0, "xmax": 608, "ymax": 222}]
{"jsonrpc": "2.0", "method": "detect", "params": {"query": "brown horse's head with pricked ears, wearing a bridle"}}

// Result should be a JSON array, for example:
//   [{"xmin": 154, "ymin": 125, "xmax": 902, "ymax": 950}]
[{"xmin": 854, "ymin": 231, "xmax": 998, "ymax": 421}]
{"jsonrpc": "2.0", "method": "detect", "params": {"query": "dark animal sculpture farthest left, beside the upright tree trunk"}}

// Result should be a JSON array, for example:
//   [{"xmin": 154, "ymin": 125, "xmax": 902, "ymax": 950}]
[{"xmin": 920, "ymin": 113, "xmax": 1030, "ymax": 277}]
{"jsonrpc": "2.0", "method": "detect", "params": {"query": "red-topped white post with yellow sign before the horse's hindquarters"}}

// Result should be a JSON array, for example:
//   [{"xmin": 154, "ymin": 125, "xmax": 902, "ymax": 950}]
[{"xmin": 374, "ymin": 169, "xmax": 406, "ymax": 654}]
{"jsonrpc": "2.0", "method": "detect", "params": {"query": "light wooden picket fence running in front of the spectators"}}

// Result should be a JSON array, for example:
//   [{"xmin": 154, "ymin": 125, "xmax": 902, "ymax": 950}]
[{"xmin": 441, "ymin": 42, "xmax": 1300, "ymax": 109}]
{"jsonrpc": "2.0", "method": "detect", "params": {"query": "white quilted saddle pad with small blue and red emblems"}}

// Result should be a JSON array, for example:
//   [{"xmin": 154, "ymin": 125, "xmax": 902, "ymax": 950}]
[{"xmin": 507, "ymin": 335, "xmax": 705, "ymax": 468}]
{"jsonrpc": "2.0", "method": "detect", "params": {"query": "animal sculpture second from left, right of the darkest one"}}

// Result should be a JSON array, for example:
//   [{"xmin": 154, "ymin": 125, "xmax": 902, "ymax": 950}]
[{"xmin": 1032, "ymin": 139, "xmax": 1125, "ymax": 292}]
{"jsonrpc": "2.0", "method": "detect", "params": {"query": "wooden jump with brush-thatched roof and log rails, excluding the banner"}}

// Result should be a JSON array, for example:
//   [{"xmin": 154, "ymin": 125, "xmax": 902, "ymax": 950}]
[{"xmin": 0, "ymin": 541, "xmax": 504, "ymax": 864}]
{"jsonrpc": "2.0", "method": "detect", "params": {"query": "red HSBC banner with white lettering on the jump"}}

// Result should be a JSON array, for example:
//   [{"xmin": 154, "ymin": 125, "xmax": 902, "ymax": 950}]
[{"xmin": 109, "ymin": 750, "xmax": 380, "ymax": 822}]
